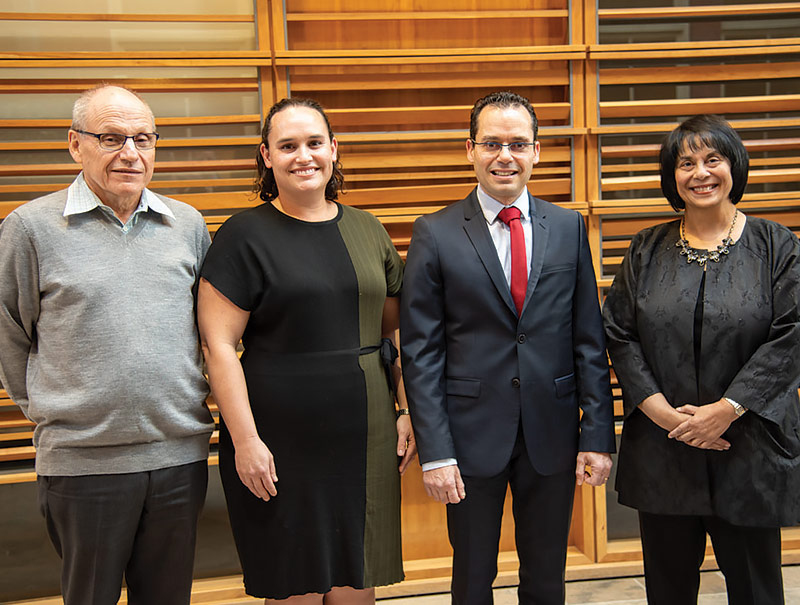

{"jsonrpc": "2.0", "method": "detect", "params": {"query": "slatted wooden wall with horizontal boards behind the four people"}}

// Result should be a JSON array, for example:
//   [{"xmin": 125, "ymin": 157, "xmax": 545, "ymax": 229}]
[{"xmin": 0, "ymin": 0, "xmax": 800, "ymax": 594}]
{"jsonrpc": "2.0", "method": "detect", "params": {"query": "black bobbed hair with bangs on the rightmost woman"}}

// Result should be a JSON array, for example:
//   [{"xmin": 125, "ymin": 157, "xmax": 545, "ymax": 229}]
[{"xmin": 660, "ymin": 114, "xmax": 750, "ymax": 212}]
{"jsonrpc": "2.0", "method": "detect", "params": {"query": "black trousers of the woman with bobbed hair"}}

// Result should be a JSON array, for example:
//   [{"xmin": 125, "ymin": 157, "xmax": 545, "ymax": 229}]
[{"xmin": 639, "ymin": 511, "xmax": 784, "ymax": 605}]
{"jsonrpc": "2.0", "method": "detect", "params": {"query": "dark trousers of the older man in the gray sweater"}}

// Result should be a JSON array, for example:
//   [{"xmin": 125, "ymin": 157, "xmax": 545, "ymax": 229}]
[{"xmin": 38, "ymin": 460, "xmax": 208, "ymax": 605}]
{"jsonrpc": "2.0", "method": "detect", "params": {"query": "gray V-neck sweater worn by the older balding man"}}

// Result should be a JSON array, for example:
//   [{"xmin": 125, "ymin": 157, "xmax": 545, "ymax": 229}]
[{"xmin": 0, "ymin": 182, "xmax": 214, "ymax": 475}]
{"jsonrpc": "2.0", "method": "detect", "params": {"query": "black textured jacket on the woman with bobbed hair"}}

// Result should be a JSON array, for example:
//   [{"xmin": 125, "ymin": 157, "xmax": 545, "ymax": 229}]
[{"xmin": 603, "ymin": 217, "xmax": 800, "ymax": 527}]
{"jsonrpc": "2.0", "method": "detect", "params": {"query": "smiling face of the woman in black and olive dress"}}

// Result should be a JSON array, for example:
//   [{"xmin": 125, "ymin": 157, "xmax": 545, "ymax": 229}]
[{"xmin": 261, "ymin": 105, "xmax": 337, "ymax": 197}]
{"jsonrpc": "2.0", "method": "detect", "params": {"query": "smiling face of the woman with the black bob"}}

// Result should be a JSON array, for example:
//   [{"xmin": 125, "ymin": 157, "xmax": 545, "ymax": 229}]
[{"xmin": 675, "ymin": 145, "xmax": 733, "ymax": 210}]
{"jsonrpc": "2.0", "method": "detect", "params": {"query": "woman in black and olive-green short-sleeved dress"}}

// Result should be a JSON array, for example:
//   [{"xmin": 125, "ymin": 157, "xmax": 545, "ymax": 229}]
[{"xmin": 198, "ymin": 99, "xmax": 416, "ymax": 605}]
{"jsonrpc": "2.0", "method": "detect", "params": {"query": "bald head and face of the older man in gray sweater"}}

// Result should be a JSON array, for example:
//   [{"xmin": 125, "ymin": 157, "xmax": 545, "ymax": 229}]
[{"xmin": 69, "ymin": 86, "xmax": 156, "ymax": 210}]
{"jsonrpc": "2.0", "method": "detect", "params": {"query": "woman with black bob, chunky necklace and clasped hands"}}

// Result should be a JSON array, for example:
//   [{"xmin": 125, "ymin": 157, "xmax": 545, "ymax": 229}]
[{"xmin": 603, "ymin": 115, "xmax": 800, "ymax": 605}]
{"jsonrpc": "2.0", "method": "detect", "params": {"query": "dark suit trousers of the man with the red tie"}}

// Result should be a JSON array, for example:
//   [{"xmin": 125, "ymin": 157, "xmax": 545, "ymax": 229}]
[{"xmin": 447, "ymin": 430, "xmax": 575, "ymax": 605}]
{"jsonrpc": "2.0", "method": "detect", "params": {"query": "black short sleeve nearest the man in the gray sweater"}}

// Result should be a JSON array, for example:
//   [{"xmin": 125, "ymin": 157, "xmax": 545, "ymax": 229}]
[{"xmin": 200, "ymin": 211, "xmax": 266, "ymax": 311}]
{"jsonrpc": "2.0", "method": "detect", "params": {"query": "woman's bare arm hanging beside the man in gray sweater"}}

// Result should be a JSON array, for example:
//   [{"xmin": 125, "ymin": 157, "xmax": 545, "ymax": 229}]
[{"xmin": 197, "ymin": 279, "xmax": 278, "ymax": 501}]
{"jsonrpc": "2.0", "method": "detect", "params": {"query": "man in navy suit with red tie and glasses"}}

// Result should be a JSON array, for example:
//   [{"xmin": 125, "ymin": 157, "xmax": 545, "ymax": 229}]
[{"xmin": 400, "ymin": 92, "xmax": 614, "ymax": 605}]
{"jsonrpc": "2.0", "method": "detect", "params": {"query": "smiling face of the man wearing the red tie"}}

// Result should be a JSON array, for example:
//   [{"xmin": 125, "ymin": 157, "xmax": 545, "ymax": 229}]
[{"xmin": 467, "ymin": 105, "xmax": 539, "ymax": 204}]
